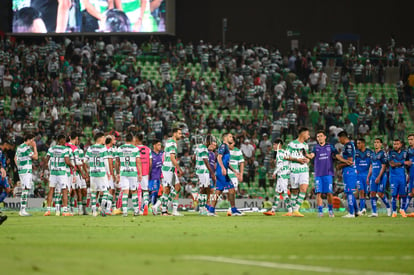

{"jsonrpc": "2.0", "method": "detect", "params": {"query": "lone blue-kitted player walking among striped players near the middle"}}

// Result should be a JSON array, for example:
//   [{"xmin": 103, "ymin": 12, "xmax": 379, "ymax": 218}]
[{"xmin": 208, "ymin": 133, "xmax": 244, "ymax": 216}]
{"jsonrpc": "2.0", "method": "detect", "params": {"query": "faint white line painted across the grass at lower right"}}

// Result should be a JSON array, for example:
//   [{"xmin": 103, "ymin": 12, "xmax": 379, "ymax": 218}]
[{"xmin": 183, "ymin": 255, "xmax": 408, "ymax": 275}]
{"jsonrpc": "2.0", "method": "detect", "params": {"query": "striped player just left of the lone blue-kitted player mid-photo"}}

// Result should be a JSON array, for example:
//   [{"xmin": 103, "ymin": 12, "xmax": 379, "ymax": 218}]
[{"xmin": 194, "ymin": 135, "xmax": 216, "ymax": 215}]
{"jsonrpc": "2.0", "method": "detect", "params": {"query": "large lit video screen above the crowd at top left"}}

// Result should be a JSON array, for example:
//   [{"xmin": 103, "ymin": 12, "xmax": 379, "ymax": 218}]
[{"xmin": 12, "ymin": 0, "xmax": 170, "ymax": 33}]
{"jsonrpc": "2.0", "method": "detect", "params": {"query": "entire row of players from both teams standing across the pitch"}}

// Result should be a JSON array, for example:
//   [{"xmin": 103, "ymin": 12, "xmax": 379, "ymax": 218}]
[{"xmin": 8, "ymin": 128, "xmax": 414, "ymax": 218}]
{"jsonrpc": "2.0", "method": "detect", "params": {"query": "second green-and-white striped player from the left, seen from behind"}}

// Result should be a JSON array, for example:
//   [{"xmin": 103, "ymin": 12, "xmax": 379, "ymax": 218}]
[{"xmin": 45, "ymin": 135, "xmax": 75, "ymax": 216}]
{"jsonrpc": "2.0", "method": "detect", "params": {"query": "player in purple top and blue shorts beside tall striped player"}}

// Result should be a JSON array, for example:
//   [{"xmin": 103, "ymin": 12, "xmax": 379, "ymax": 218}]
[{"xmin": 310, "ymin": 130, "xmax": 340, "ymax": 218}]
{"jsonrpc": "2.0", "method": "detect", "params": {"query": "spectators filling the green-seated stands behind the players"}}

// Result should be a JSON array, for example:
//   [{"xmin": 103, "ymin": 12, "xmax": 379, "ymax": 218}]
[{"xmin": 0, "ymin": 37, "xmax": 414, "ymax": 210}]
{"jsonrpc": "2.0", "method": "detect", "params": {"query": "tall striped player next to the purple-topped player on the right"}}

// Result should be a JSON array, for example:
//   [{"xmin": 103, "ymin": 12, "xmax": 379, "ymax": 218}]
[{"xmin": 286, "ymin": 127, "xmax": 310, "ymax": 217}]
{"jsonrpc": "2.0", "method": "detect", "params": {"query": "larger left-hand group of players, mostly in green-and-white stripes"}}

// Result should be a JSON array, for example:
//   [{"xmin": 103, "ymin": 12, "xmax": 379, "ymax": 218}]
[{"xmin": 15, "ymin": 128, "xmax": 243, "ymax": 216}]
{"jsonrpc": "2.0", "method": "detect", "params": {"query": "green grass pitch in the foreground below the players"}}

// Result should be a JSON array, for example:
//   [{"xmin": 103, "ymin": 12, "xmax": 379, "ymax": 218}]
[{"xmin": 0, "ymin": 212, "xmax": 414, "ymax": 275}]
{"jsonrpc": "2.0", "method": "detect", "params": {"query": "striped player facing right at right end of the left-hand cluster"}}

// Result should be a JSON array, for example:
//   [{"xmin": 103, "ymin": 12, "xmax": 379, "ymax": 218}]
[{"xmin": 157, "ymin": 128, "xmax": 183, "ymax": 216}]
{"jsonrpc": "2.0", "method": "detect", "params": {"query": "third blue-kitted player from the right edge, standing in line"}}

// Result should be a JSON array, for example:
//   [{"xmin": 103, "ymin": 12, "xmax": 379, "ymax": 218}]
[{"xmin": 367, "ymin": 138, "xmax": 391, "ymax": 218}]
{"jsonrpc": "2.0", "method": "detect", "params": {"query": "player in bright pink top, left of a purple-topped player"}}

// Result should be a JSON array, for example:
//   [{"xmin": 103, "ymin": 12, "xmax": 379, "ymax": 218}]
[{"xmin": 135, "ymin": 134, "xmax": 152, "ymax": 216}]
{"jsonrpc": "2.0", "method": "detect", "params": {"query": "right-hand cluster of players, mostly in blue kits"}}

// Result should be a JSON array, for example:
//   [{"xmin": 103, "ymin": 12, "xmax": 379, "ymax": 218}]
[{"xmin": 264, "ymin": 128, "xmax": 414, "ymax": 218}]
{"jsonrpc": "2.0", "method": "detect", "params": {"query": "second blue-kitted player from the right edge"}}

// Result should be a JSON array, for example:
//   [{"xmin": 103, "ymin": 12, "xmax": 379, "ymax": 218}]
[{"xmin": 388, "ymin": 139, "xmax": 409, "ymax": 218}]
